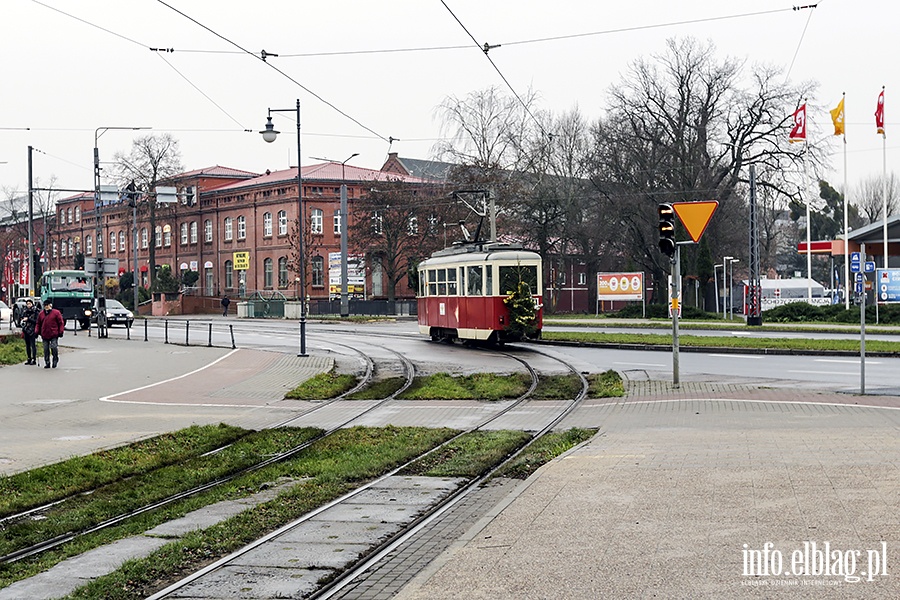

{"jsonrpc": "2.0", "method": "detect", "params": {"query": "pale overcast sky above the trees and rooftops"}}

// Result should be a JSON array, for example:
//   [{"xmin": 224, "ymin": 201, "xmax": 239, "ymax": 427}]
[{"xmin": 0, "ymin": 0, "xmax": 900, "ymax": 203}]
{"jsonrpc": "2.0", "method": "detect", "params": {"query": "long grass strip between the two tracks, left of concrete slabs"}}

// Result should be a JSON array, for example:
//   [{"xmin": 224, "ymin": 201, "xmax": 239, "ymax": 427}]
[{"xmin": 59, "ymin": 426, "xmax": 453, "ymax": 600}]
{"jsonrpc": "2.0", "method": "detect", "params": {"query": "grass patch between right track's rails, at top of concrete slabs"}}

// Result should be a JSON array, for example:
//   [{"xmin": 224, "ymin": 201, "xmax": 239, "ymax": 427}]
[{"xmin": 402, "ymin": 430, "xmax": 531, "ymax": 478}]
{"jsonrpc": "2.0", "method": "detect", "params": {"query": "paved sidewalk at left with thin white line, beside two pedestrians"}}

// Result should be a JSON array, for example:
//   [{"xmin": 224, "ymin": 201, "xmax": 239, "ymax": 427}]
[{"xmin": 0, "ymin": 332, "xmax": 332, "ymax": 474}]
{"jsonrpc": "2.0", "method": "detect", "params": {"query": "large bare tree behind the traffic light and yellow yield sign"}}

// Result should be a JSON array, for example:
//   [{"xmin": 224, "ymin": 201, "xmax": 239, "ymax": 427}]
[{"xmin": 593, "ymin": 38, "xmax": 825, "ymax": 300}]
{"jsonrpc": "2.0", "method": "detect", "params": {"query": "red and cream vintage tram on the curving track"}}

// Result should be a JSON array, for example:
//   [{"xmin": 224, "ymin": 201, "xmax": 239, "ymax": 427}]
[{"xmin": 418, "ymin": 242, "xmax": 543, "ymax": 344}]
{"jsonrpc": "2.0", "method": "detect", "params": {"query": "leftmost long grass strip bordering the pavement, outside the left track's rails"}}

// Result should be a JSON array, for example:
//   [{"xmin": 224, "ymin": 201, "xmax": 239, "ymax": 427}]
[{"xmin": 0, "ymin": 424, "xmax": 249, "ymax": 516}]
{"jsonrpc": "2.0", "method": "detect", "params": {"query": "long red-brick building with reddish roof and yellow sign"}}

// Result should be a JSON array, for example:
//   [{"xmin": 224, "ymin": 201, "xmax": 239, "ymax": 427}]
[{"xmin": 48, "ymin": 162, "xmax": 435, "ymax": 299}]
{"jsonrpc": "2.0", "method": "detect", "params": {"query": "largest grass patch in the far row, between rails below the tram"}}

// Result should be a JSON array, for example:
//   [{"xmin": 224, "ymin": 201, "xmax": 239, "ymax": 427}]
[{"xmin": 398, "ymin": 373, "xmax": 531, "ymax": 400}]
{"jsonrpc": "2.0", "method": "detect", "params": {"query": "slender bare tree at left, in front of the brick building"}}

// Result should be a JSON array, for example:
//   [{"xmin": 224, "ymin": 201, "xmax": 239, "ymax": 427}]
[{"xmin": 114, "ymin": 133, "xmax": 184, "ymax": 284}]
